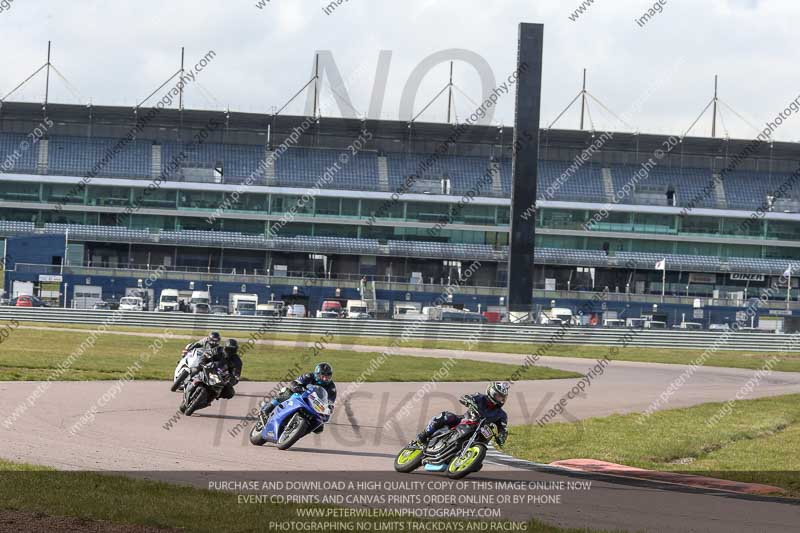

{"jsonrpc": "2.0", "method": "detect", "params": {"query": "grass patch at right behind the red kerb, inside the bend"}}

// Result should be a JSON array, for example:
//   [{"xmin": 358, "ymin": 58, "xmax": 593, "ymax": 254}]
[{"xmin": 506, "ymin": 394, "xmax": 800, "ymax": 497}]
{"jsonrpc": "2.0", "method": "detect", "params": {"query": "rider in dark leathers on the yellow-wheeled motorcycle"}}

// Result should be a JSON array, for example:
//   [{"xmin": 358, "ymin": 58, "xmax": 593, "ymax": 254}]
[{"xmin": 417, "ymin": 381, "xmax": 509, "ymax": 446}]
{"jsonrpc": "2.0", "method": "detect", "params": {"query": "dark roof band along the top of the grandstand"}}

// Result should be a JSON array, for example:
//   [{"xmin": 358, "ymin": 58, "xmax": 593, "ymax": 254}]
[{"xmin": 0, "ymin": 102, "xmax": 800, "ymax": 161}]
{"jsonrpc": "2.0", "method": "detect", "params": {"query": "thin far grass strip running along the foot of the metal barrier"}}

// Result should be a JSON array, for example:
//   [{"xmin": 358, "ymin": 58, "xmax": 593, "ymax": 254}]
[{"xmin": 10, "ymin": 322, "xmax": 800, "ymax": 372}]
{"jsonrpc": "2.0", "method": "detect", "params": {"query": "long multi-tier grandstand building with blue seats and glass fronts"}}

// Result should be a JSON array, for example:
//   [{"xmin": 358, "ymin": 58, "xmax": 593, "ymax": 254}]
[{"xmin": 0, "ymin": 103, "xmax": 800, "ymax": 322}]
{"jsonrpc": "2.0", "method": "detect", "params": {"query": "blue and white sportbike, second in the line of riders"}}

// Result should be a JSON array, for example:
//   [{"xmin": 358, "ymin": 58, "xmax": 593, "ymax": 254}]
[{"xmin": 250, "ymin": 384, "xmax": 333, "ymax": 450}]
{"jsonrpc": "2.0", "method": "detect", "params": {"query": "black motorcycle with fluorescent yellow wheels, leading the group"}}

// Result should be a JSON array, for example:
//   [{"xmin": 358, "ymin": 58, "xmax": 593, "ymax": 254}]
[{"xmin": 394, "ymin": 413, "xmax": 498, "ymax": 479}]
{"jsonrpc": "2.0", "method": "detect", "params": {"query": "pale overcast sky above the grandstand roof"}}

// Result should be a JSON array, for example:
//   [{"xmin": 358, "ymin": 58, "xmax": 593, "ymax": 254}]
[{"xmin": 0, "ymin": 0, "xmax": 800, "ymax": 141}]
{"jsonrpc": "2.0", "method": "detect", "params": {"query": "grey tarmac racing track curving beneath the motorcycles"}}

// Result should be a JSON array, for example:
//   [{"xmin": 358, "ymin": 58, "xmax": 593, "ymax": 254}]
[{"xmin": 0, "ymin": 346, "xmax": 800, "ymax": 533}]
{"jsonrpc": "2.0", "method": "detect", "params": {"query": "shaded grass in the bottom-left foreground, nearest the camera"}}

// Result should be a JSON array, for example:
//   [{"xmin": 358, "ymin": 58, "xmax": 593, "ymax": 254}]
[{"xmin": 0, "ymin": 460, "xmax": 616, "ymax": 533}]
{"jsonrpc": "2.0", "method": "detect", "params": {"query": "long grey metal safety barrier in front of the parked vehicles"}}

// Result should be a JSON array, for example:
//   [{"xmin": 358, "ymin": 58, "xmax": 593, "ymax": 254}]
[{"xmin": 0, "ymin": 307, "xmax": 800, "ymax": 352}]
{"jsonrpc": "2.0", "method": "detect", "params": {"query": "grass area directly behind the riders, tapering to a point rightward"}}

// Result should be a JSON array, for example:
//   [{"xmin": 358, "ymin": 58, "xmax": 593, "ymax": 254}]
[{"xmin": 0, "ymin": 328, "xmax": 578, "ymax": 382}]
